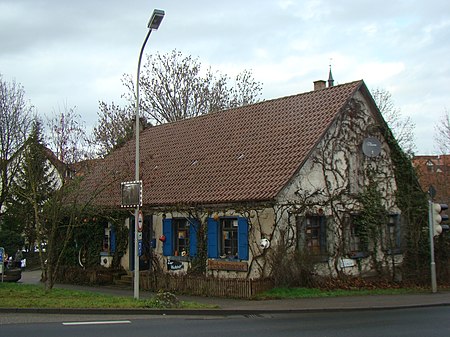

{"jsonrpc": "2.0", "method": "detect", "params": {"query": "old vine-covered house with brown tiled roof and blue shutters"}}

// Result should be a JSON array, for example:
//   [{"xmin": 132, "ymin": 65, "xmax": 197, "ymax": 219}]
[{"xmin": 80, "ymin": 81, "xmax": 401, "ymax": 278}]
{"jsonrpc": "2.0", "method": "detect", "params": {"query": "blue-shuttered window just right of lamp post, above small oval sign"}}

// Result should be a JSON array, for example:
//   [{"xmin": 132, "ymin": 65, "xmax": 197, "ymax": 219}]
[{"xmin": 163, "ymin": 218, "xmax": 198, "ymax": 256}]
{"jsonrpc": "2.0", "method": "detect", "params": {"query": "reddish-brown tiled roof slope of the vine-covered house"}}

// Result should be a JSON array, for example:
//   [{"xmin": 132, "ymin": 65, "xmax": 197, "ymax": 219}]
[{"xmin": 81, "ymin": 81, "xmax": 365, "ymax": 206}]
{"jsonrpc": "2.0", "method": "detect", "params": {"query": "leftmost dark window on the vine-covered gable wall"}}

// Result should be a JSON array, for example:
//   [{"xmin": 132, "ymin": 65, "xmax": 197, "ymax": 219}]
[{"xmin": 297, "ymin": 215, "xmax": 327, "ymax": 255}]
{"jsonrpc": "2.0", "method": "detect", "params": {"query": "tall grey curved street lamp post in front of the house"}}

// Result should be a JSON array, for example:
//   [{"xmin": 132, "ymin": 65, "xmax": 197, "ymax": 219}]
[{"xmin": 134, "ymin": 9, "xmax": 164, "ymax": 299}]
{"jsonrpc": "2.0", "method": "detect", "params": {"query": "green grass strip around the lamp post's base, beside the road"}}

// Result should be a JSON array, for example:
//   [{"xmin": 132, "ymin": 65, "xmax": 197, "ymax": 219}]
[{"xmin": 0, "ymin": 283, "xmax": 211, "ymax": 309}]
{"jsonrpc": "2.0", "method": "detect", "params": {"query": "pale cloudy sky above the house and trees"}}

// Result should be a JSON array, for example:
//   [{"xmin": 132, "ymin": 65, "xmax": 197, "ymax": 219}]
[{"xmin": 0, "ymin": 0, "xmax": 450, "ymax": 154}]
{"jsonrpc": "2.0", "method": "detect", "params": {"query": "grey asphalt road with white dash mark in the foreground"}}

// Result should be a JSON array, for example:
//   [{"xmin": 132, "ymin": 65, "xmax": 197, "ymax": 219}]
[{"xmin": 0, "ymin": 306, "xmax": 450, "ymax": 337}]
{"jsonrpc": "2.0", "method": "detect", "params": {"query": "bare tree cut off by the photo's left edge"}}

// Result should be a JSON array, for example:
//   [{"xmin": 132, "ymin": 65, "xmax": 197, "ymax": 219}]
[{"xmin": 0, "ymin": 74, "xmax": 33, "ymax": 215}]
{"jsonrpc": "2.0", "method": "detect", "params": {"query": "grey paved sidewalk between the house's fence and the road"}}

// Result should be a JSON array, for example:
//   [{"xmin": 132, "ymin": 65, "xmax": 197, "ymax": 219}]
[{"xmin": 8, "ymin": 271, "xmax": 450, "ymax": 315}]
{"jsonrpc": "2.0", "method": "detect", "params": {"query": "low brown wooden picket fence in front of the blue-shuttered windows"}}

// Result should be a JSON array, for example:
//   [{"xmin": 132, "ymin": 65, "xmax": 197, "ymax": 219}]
[{"xmin": 140, "ymin": 273, "xmax": 273, "ymax": 298}]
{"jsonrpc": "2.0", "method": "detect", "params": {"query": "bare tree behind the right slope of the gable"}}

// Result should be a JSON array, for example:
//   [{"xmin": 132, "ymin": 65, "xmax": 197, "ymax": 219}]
[{"xmin": 372, "ymin": 88, "xmax": 416, "ymax": 155}]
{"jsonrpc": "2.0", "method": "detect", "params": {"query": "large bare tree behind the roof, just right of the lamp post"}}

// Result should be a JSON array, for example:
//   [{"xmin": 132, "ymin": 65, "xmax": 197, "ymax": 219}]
[{"xmin": 124, "ymin": 50, "xmax": 261, "ymax": 124}]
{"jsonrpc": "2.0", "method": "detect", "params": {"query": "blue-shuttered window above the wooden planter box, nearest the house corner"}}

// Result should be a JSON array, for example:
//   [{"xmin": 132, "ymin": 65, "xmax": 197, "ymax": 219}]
[{"xmin": 208, "ymin": 217, "xmax": 249, "ymax": 260}]
